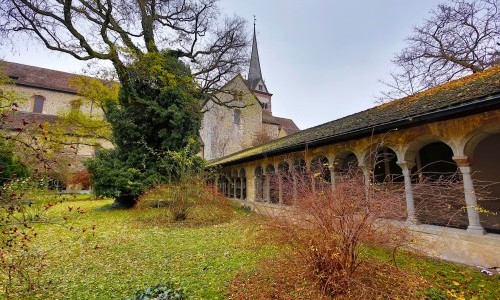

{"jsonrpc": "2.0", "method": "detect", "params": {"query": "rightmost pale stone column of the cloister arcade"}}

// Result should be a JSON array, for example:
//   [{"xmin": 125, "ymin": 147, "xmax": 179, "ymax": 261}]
[{"xmin": 452, "ymin": 156, "xmax": 486, "ymax": 234}]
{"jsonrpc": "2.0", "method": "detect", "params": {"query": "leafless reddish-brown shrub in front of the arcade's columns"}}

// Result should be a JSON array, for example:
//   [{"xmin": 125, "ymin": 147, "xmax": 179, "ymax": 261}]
[{"xmin": 262, "ymin": 170, "xmax": 411, "ymax": 295}]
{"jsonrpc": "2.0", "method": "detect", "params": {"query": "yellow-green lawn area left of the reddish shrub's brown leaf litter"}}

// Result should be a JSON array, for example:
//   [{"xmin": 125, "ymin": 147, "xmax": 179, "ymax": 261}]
[{"xmin": 21, "ymin": 200, "xmax": 275, "ymax": 299}]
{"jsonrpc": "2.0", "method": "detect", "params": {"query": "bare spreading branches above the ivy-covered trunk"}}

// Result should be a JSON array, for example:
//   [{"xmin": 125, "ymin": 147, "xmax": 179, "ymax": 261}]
[{"xmin": 0, "ymin": 0, "xmax": 248, "ymax": 108}]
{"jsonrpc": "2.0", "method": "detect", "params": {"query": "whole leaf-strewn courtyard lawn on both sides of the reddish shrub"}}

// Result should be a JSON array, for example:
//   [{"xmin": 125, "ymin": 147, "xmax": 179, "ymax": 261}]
[{"xmin": 0, "ymin": 195, "xmax": 500, "ymax": 299}]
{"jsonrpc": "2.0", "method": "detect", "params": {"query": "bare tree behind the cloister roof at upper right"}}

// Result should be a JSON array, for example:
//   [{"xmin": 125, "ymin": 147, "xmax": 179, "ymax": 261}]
[{"xmin": 378, "ymin": 0, "xmax": 500, "ymax": 101}]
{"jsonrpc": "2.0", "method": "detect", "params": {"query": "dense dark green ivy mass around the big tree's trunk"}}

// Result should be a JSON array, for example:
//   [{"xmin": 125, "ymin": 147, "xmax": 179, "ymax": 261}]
[{"xmin": 87, "ymin": 51, "xmax": 202, "ymax": 206}]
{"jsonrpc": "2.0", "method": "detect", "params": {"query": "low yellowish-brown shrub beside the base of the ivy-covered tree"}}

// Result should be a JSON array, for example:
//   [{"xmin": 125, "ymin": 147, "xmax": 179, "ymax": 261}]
[{"xmin": 136, "ymin": 177, "xmax": 233, "ymax": 224}]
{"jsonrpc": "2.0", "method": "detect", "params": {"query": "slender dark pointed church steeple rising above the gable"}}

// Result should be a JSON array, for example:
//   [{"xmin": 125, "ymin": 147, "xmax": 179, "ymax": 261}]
[{"xmin": 247, "ymin": 19, "xmax": 273, "ymax": 112}]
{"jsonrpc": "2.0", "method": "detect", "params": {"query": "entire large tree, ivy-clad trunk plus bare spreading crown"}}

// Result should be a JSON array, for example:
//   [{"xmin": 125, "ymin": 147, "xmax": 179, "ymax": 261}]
[{"xmin": 0, "ymin": 0, "xmax": 249, "ymax": 204}]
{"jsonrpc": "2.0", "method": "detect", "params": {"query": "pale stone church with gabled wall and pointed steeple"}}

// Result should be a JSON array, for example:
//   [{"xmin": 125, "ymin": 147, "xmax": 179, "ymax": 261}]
[{"xmin": 200, "ymin": 28, "xmax": 299, "ymax": 160}]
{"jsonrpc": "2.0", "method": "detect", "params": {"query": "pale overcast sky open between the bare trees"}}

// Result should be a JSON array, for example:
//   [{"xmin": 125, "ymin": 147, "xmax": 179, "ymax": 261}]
[{"xmin": 0, "ymin": 0, "xmax": 443, "ymax": 129}]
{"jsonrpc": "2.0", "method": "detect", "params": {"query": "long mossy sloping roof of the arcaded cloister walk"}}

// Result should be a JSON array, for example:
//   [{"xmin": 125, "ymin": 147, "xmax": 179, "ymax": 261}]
[{"xmin": 209, "ymin": 66, "xmax": 500, "ymax": 165}]
